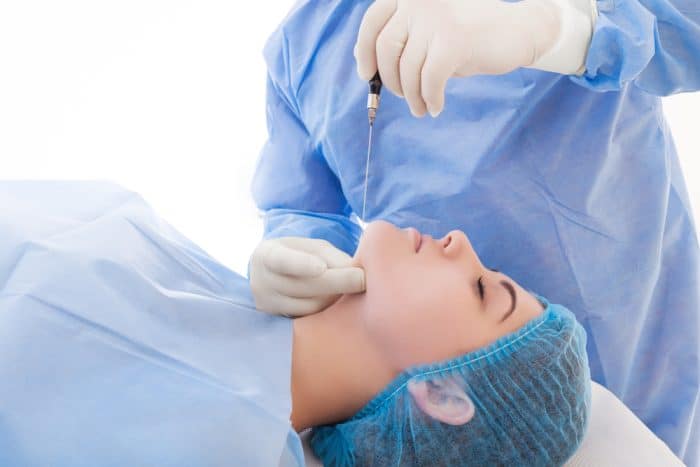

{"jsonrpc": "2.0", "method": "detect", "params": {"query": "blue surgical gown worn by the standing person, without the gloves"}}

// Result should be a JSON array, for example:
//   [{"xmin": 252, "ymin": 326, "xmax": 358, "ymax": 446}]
[{"xmin": 252, "ymin": 0, "xmax": 700, "ymax": 465}]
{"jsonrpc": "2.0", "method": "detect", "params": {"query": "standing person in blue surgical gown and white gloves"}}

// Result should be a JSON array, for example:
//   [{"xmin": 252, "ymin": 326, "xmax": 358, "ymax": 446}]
[{"xmin": 250, "ymin": 0, "xmax": 700, "ymax": 466}]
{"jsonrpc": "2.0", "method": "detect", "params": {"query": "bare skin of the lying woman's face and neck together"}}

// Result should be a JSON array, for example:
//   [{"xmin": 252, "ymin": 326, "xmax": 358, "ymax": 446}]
[{"xmin": 291, "ymin": 221, "xmax": 542, "ymax": 431}]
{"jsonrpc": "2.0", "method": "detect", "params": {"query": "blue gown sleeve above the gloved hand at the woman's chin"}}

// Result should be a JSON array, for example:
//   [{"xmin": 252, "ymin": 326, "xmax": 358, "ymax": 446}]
[{"xmin": 252, "ymin": 25, "xmax": 361, "ymax": 255}]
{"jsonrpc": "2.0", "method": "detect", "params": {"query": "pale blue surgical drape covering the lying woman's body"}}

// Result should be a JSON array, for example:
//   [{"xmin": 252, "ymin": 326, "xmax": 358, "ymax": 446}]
[{"xmin": 0, "ymin": 182, "xmax": 304, "ymax": 467}]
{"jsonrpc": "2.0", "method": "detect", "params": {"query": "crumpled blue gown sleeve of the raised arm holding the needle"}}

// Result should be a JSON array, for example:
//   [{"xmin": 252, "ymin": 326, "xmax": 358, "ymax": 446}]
[{"xmin": 571, "ymin": 0, "xmax": 700, "ymax": 96}]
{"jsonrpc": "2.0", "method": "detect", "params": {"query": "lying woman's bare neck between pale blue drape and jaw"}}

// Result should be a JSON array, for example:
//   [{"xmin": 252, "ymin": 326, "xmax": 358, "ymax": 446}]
[{"xmin": 291, "ymin": 295, "xmax": 398, "ymax": 431}]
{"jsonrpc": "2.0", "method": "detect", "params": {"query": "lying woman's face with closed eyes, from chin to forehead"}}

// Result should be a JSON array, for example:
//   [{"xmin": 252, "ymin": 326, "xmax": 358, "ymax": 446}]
[{"xmin": 354, "ymin": 221, "xmax": 542, "ymax": 370}]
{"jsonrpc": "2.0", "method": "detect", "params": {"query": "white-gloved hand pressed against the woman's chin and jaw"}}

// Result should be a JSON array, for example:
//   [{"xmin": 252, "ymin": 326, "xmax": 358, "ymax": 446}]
[{"xmin": 249, "ymin": 237, "xmax": 365, "ymax": 316}]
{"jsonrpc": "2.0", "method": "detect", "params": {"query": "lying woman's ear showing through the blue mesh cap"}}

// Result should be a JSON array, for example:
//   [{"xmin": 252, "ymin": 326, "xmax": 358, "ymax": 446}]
[{"xmin": 408, "ymin": 378, "xmax": 474, "ymax": 425}]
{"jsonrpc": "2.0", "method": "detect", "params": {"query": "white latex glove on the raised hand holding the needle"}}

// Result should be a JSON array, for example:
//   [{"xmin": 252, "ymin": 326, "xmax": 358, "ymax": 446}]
[{"xmin": 355, "ymin": 0, "xmax": 597, "ymax": 116}]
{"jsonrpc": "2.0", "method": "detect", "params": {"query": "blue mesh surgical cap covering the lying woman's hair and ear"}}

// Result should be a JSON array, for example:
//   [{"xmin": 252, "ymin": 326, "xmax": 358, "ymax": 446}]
[{"xmin": 311, "ymin": 297, "xmax": 590, "ymax": 467}]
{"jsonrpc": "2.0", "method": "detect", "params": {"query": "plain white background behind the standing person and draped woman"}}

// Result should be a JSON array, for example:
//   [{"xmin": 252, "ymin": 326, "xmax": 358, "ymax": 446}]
[{"xmin": 0, "ymin": 0, "xmax": 700, "ymax": 274}]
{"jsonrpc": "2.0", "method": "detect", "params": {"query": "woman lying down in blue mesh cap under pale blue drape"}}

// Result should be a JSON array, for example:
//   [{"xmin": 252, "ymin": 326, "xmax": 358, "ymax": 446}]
[{"xmin": 0, "ymin": 182, "xmax": 680, "ymax": 466}]
